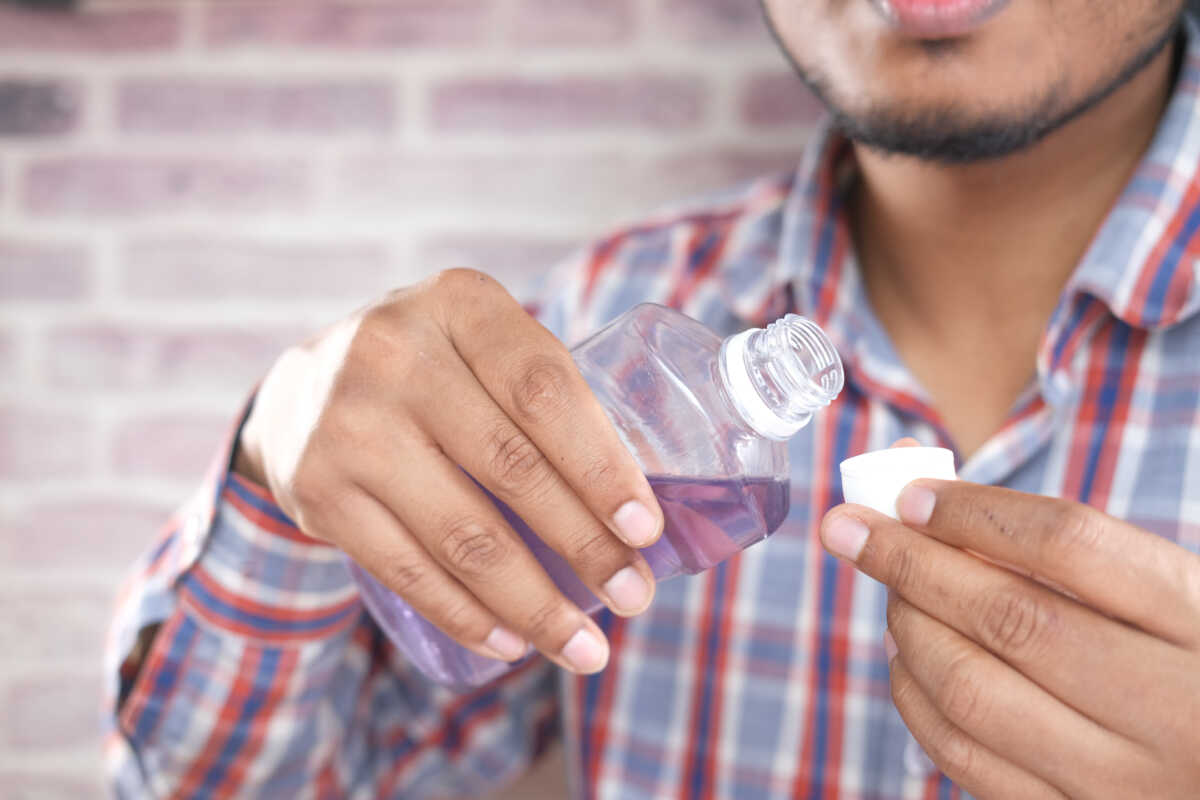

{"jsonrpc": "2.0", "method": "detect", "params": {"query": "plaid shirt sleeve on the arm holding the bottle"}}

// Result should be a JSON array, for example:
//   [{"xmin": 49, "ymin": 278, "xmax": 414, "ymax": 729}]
[{"xmin": 104, "ymin": 398, "xmax": 557, "ymax": 798}]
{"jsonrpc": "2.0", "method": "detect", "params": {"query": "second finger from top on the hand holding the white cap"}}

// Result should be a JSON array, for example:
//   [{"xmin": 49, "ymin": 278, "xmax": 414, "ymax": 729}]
[{"xmin": 821, "ymin": 505, "xmax": 1190, "ymax": 742}]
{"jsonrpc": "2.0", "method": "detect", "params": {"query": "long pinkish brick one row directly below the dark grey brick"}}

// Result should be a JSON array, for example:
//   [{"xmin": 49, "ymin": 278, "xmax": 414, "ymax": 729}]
[{"xmin": 24, "ymin": 156, "xmax": 308, "ymax": 217}]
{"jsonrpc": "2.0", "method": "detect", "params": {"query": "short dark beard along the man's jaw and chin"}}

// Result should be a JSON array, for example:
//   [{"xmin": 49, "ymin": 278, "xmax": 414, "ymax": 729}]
[{"xmin": 764, "ymin": 11, "xmax": 1183, "ymax": 164}]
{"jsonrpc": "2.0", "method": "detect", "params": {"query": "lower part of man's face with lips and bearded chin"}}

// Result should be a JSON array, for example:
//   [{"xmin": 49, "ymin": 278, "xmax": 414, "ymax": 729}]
[{"xmin": 763, "ymin": 0, "xmax": 1183, "ymax": 162}]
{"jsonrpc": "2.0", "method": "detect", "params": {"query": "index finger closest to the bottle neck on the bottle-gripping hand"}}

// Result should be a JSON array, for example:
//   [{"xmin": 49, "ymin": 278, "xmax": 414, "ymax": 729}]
[{"xmin": 449, "ymin": 273, "xmax": 664, "ymax": 547}]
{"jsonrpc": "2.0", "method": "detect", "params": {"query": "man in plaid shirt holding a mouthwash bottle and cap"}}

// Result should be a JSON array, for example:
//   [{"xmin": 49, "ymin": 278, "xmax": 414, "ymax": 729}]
[{"xmin": 105, "ymin": 0, "xmax": 1200, "ymax": 799}]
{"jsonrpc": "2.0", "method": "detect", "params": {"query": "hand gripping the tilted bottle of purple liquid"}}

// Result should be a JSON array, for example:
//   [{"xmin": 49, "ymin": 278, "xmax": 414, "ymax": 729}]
[{"xmin": 235, "ymin": 270, "xmax": 662, "ymax": 673}]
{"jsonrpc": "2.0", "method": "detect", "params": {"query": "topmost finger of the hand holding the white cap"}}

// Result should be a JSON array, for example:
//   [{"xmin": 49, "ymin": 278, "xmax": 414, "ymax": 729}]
[{"xmin": 896, "ymin": 480, "xmax": 1200, "ymax": 645}]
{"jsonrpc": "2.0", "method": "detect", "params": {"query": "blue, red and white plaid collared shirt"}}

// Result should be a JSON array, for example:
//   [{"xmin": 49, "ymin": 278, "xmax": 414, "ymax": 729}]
[{"xmin": 107, "ymin": 23, "xmax": 1200, "ymax": 800}]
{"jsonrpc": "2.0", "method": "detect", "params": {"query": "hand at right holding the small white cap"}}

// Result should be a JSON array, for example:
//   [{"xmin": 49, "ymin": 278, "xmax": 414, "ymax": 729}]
[{"xmin": 821, "ymin": 480, "xmax": 1200, "ymax": 798}]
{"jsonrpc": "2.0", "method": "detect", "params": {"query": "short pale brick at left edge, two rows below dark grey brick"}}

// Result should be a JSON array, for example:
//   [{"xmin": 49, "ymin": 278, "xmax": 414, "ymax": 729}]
[{"xmin": 0, "ymin": 239, "xmax": 92, "ymax": 301}]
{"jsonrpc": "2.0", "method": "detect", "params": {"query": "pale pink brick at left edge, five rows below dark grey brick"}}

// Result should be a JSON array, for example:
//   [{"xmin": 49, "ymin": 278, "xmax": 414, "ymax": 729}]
[{"xmin": 0, "ymin": 496, "xmax": 174, "ymax": 573}]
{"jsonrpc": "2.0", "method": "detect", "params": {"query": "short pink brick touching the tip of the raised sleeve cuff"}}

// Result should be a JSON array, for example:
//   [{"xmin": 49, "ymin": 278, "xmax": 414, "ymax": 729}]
[{"xmin": 112, "ymin": 414, "xmax": 240, "ymax": 482}]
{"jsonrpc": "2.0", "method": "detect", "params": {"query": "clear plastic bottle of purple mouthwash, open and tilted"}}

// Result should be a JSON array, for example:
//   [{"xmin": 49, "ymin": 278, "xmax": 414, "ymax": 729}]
[{"xmin": 349, "ymin": 303, "xmax": 844, "ymax": 688}]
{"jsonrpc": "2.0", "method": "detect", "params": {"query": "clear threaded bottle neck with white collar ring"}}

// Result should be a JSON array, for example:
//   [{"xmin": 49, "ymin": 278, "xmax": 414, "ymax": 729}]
[{"xmin": 720, "ymin": 314, "xmax": 845, "ymax": 441}]
